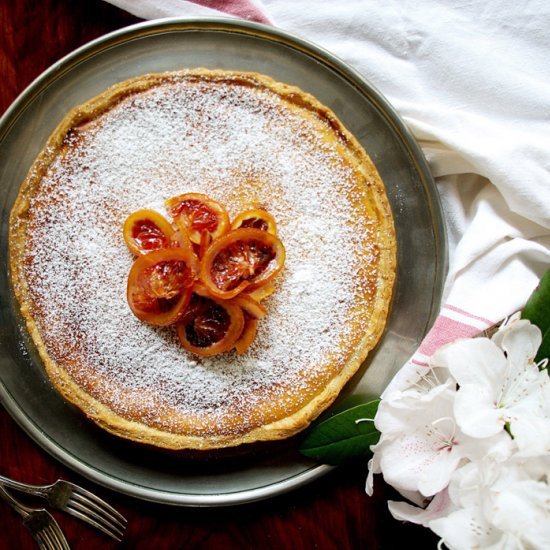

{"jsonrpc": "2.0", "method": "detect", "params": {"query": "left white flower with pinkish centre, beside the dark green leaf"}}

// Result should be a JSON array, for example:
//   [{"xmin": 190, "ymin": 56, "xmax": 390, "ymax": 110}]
[{"xmin": 372, "ymin": 380, "xmax": 510, "ymax": 497}]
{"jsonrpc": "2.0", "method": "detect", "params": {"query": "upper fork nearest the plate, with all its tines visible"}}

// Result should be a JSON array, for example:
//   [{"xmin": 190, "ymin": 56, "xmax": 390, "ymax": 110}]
[{"xmin": 0, "ymin": 475, "xmax": 126, "ymax": 541}]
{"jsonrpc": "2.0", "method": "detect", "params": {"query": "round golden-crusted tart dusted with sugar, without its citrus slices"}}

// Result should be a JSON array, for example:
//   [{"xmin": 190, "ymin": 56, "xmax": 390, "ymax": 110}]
[{"xmin": 9, "ymin": 69, "xmax": 396, "ymax": 450}]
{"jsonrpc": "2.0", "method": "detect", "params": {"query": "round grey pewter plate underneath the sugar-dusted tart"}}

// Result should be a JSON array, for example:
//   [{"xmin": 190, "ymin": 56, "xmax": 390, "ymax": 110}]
[{"xmin": 0, "ymin": 19, "xmax": 447, "ymax": 506}]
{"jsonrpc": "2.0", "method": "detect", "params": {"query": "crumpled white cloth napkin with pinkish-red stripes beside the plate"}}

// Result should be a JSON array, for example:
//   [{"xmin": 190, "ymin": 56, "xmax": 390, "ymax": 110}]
[{"xmin": 103, "ymin": 0, "xmax": 550, "ymax": 380}]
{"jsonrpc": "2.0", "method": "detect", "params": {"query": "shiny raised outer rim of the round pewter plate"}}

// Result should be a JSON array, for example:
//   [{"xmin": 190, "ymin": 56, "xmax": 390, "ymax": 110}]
[{"xmin": 0, "ymin": 17, "xmax": 448, "ymax": 507}]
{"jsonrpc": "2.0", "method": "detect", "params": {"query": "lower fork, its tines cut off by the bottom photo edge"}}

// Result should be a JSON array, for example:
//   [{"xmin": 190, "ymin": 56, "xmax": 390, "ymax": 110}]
[{"xmin": 0, "ymin": 486, "xmax": 70, "ymax": 550}]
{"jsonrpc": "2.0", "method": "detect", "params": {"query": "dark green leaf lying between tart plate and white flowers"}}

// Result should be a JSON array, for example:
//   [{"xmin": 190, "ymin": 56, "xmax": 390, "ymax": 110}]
[{"xmin": 300, "ymin": 399, "xmax": 380, "ymax": 465}]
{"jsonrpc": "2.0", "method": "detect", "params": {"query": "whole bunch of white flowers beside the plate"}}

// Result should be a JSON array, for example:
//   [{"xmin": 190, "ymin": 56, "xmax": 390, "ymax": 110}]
[{"xmin": 367, "ymin": 319, "xmax": 550, "ymax": 550}]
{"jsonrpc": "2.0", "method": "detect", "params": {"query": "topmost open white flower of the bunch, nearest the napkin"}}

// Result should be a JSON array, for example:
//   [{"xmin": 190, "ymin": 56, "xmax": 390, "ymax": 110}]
[{"xmin": 432, "ymin": 321, "xmax": 550, "ymax": 454}]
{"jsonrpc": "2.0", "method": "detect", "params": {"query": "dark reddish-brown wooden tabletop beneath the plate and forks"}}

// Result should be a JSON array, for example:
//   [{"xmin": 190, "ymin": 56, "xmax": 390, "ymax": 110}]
[{"xmin": 0, "ymin": 0, "xmax": 437, "ymax": 550}]
